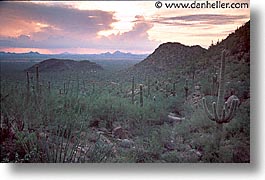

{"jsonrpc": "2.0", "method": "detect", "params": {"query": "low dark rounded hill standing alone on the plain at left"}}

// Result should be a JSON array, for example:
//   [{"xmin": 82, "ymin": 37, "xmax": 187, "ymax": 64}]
[{"xmin": 25, "ymin": 59, "xmax": 103, "ymax": 72}]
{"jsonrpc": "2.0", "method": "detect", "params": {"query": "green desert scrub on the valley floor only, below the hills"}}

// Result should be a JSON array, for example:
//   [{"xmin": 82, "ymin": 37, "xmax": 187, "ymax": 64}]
[{"xmin": 1, "ymin": 53, "xmax": 249, "ymax": 162}]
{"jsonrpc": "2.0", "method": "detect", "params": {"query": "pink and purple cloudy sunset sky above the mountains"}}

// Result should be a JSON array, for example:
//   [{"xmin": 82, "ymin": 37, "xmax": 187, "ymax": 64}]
[{"xmin": 0, "ymin": 0, "xmax": 250, "ymax": 54}]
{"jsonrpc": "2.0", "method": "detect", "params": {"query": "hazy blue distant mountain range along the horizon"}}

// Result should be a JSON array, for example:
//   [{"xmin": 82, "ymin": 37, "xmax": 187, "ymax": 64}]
[{"xmin": 0, "ymin": 51, "xmax": 148, "ymax": 62}]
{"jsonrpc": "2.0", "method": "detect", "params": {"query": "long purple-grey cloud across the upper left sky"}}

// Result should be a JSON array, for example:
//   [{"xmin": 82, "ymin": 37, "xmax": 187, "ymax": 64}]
[{"xmin": 0, "ymin": 2, "xmax": 116, "ymax": 33}]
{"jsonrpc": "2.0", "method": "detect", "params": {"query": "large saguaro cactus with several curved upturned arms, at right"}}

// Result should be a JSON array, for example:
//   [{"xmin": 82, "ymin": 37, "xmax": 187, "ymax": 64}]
[{"xmin": 203, "ymin": 50, "xmax": 239, "ymax": 149}]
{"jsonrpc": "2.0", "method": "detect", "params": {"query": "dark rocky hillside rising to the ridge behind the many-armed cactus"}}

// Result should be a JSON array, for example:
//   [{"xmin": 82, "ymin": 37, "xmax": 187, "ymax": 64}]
[{"xmin": 122, "ymin": 21, "xmax": 250, "ymax": 99}]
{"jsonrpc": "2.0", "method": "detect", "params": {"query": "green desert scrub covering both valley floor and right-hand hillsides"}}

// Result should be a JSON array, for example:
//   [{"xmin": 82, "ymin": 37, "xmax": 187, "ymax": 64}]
[{"xmin": 0, "ymin": 22, "xmax": 250, "ymax": 163}]
